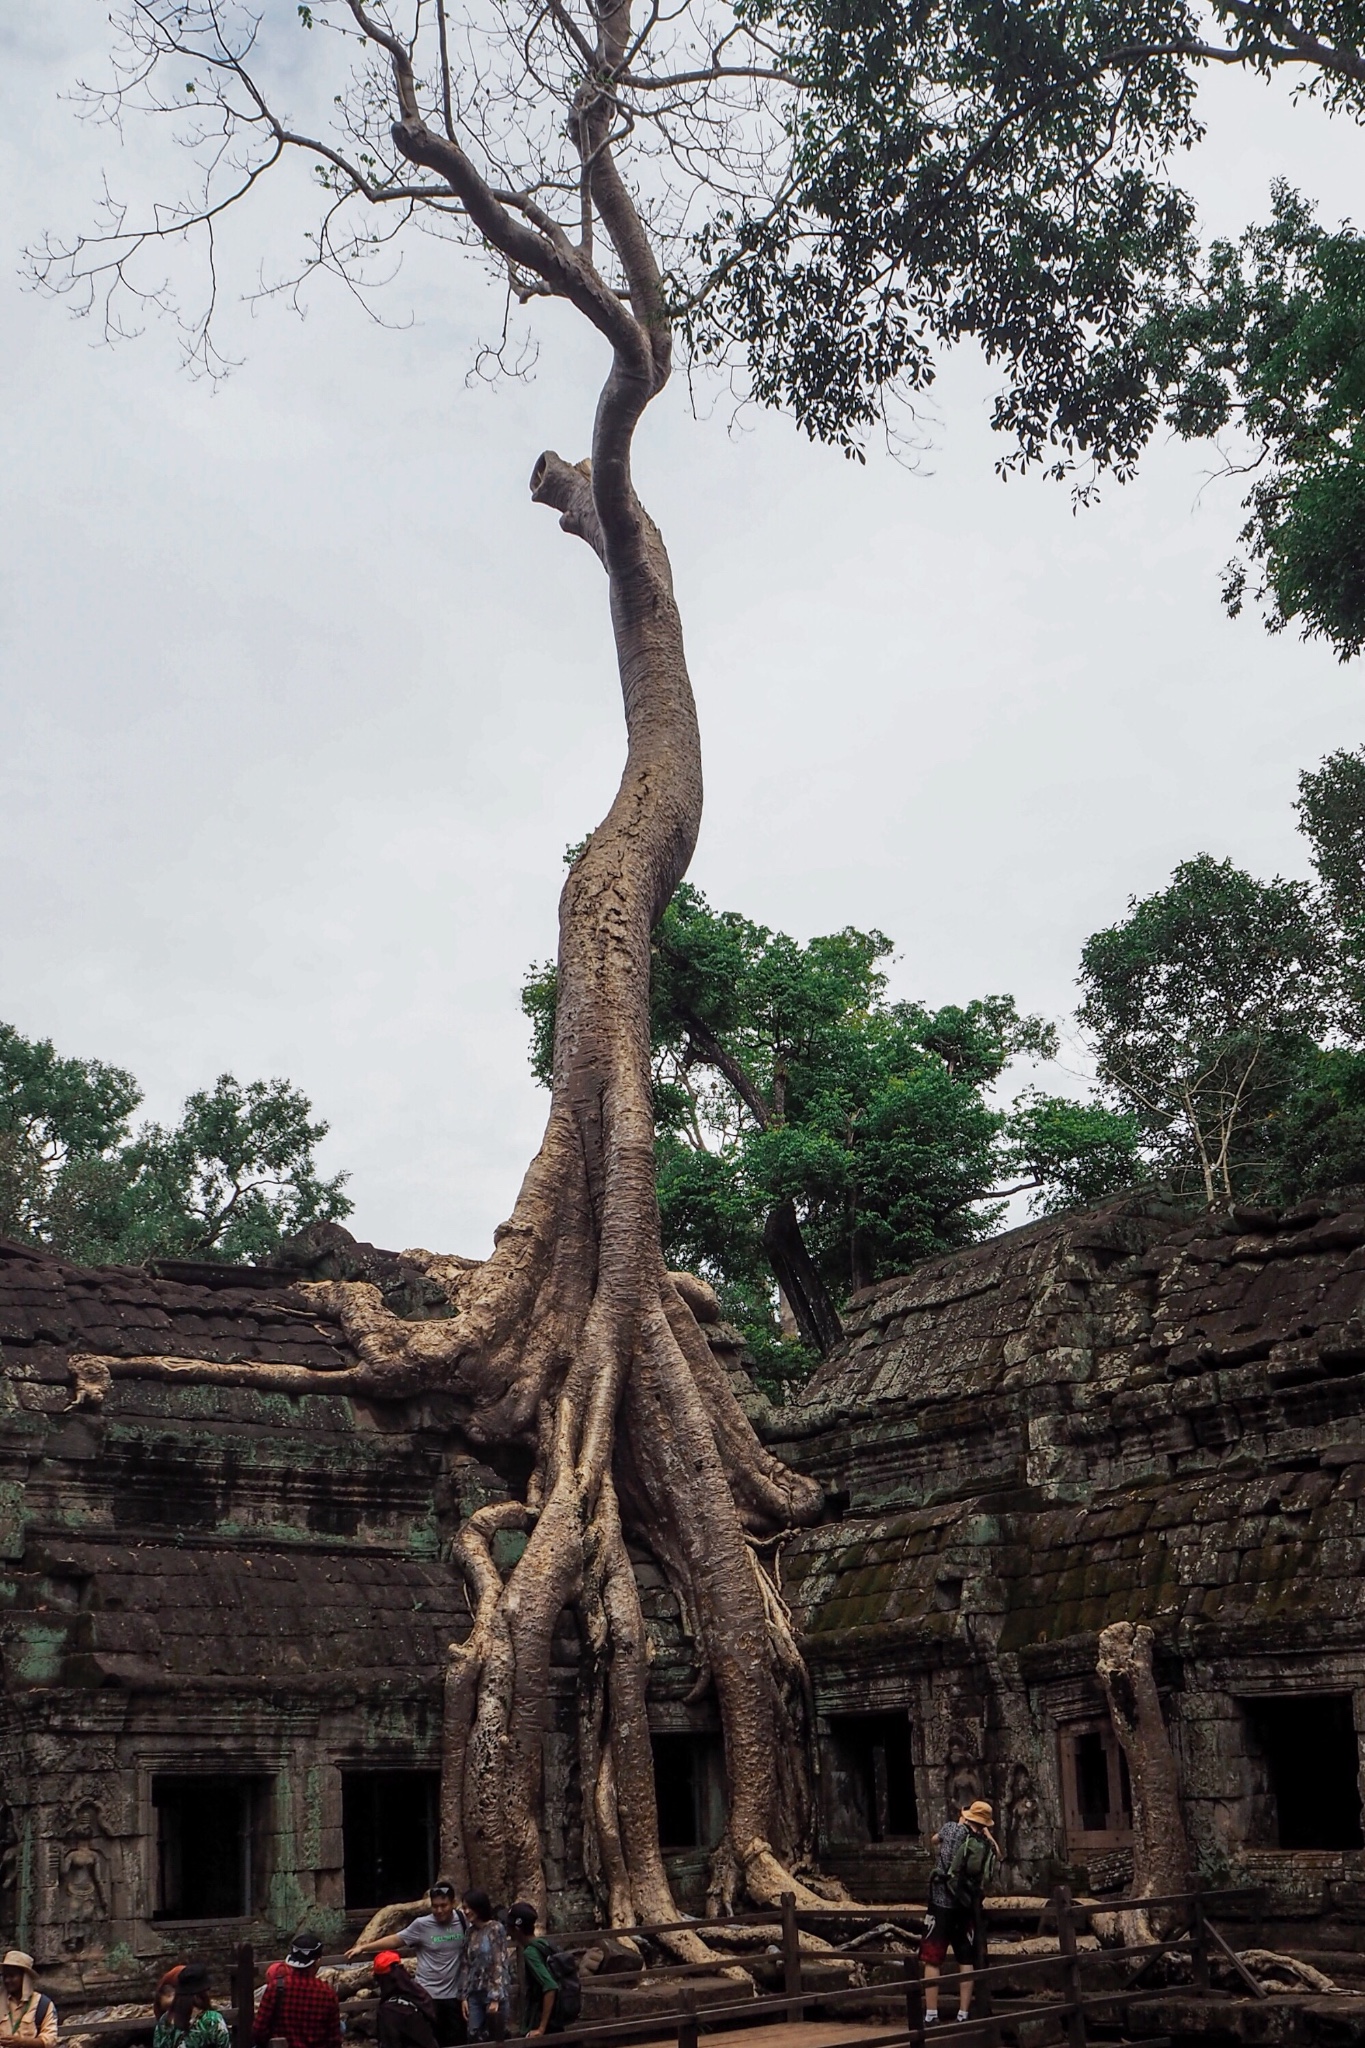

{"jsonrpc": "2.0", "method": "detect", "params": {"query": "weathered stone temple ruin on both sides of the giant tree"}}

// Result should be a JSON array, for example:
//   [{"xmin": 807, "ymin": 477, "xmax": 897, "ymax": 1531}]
[{"xmin": 0, "ymin": 1200, "xmax": 1365, "ymax": 1989}]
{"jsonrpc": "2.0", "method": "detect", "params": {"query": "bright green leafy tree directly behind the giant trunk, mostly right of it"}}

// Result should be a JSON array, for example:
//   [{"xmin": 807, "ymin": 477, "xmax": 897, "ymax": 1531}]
[{"xmin": 522, "ymin": 883, "xmax": 1142, "ymax": 1391}]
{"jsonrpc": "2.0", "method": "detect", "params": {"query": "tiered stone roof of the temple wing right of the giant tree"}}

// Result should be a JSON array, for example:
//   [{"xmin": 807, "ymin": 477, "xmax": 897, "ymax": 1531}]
[{"xmin": 769, "ymin": 1200, "xmax": 1365, "ymax": 1659}]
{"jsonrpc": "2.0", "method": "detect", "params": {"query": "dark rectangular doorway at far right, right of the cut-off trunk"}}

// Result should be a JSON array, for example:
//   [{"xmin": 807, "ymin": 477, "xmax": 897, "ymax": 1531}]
[{"xmin": 1242, "ymin": 1692, "xmax": 1365, "ymax": 1849}]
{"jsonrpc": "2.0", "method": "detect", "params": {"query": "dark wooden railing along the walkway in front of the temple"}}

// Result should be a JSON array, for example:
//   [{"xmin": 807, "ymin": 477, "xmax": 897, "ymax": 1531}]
[{"xmin": 63, "ymin": 1886, "xmax": 1265, "ymax": 2048}]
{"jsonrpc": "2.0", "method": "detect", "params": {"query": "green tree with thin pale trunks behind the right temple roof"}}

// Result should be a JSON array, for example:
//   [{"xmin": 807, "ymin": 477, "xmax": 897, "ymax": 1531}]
[{"xmin": 1078, "ymin": 750, "xmax": 1365, "ymax": 1204}]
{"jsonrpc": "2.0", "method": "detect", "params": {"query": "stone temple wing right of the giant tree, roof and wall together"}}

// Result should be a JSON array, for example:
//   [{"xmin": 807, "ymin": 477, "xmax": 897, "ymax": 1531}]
[{"xmin": 765, "ymin": 1202, "xmax": 1365, "ymax": 1946}]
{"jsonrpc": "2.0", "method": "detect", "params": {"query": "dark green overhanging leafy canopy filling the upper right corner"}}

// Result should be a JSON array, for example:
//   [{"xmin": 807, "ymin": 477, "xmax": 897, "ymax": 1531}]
[{"xmin": 688, "ymin": 0, "xmax": 1365, "ymax": 659}]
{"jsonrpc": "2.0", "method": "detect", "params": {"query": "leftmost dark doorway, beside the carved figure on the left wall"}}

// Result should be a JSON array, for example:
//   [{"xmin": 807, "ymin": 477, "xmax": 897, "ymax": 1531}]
[{"xmin": 151, "ymin": 1778, "xmax": 270, "ymax": 1919}]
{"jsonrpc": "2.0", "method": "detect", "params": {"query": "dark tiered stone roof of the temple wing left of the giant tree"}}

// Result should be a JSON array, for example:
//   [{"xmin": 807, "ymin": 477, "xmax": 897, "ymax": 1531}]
[{"xmin": 0, "ymin": 1241, "xmax": 474, "ymax": 1696}]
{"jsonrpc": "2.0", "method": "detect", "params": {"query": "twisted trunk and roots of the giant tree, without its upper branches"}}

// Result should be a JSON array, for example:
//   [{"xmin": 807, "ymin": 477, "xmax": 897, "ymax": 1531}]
[{"xmin": 302, "ymin": 419, "xmax": 821, "ymax": 1946}]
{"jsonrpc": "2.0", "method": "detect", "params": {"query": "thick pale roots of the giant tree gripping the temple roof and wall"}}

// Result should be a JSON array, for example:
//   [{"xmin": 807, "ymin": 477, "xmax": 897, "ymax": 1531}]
[{"xmin": 296, "ymin": 1204, "xmax": 823, "ymax": 1925}]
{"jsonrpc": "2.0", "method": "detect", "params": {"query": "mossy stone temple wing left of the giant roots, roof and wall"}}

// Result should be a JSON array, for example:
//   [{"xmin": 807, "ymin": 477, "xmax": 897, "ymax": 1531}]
[{"xmin": 0, "ymin": 1231, "xmax": 718, "ymax": 1991}]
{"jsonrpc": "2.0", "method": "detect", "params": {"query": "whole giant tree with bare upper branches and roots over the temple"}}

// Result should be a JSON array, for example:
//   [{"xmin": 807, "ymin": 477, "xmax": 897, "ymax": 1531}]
[{"xmin": 37, "ymin": 0, "xmax": 847, "ymax": 1925}]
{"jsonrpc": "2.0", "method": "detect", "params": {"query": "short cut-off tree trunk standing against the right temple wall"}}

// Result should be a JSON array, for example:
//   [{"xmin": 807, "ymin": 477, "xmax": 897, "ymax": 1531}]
[{"xmin": 1097, "ymin": 1622, "xmax": 1189, "ymax": 1942}]
